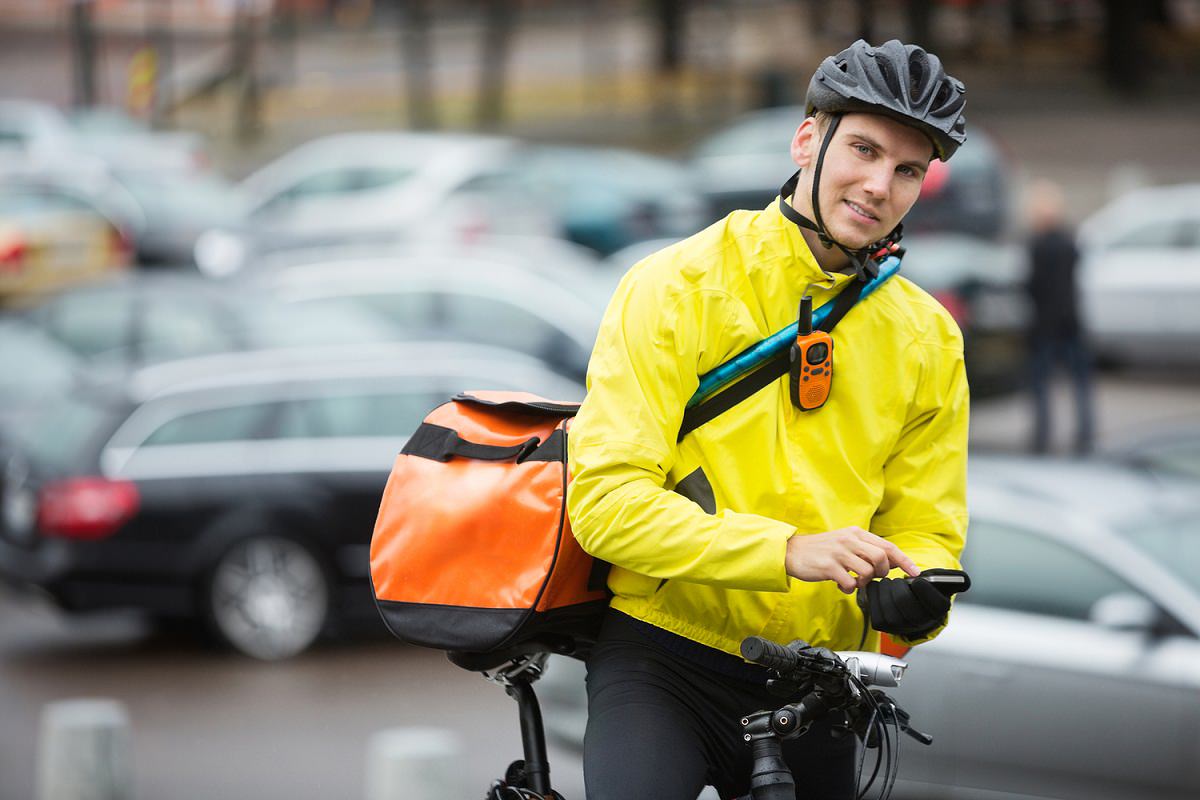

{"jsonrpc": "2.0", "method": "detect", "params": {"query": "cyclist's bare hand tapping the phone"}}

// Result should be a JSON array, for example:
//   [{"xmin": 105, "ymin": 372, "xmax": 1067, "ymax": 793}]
[{"xmin": 784, "ymin": 528, "xmax": 920, "ymax": 595}]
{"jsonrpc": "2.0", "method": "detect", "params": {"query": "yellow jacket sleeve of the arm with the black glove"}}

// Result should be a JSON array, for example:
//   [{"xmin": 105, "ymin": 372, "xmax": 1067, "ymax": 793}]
[{"xmin": 871, "ymin": 329, "xmax": 970, "ymax": 642}]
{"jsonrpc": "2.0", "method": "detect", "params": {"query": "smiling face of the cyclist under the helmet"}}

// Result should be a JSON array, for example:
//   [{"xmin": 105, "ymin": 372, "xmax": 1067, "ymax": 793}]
[{"xmin": 792, "ymin": 114, "xmax": 932, "ymax": 249}]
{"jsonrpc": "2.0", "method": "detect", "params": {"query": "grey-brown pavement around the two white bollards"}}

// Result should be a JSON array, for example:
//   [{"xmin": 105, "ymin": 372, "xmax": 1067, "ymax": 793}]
[{"xmin": 0, "ymin": 589, "xmax": 583, "ymax": 800}]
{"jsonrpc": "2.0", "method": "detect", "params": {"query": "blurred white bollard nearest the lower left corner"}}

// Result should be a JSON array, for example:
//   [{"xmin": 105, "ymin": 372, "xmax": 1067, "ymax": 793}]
[{"xmin": 37, "ymin": 699, "xmax": 133, "ymax": 800}]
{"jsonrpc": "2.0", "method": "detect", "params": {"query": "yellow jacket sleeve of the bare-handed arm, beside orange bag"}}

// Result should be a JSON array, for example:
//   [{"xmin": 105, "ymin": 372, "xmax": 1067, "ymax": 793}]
[{"xmin": 568, "ymin": 261, "xmax": 796, "ymax": 591}]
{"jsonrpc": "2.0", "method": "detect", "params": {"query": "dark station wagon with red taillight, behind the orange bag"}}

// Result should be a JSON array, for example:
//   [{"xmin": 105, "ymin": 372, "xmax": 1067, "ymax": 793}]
[{"xmin": 0, "ymin": 342, "xmax": 583, "ymax": 660}]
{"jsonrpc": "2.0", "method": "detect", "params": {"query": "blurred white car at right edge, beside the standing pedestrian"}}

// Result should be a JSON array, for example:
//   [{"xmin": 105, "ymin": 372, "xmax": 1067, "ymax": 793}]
[{"xmin": 1079, "ymin": 184, "xmax": 1200, "ymax": 366}]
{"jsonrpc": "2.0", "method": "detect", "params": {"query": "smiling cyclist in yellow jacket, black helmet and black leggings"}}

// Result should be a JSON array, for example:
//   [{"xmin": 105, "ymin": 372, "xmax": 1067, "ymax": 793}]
[{"xmin": 568, "ymin": 41, "xmax": 967, "ymax": 800}]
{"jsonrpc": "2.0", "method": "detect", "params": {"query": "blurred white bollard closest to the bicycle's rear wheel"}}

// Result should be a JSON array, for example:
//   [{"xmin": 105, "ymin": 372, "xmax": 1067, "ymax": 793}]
[{"xmin": 366, "ymin": 728, "xmax": 460, "ymax": 800}]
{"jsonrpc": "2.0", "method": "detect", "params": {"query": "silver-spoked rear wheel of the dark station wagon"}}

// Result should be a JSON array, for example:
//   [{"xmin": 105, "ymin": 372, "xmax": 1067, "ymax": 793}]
[{"xmin": 206, "ymin": 536, "xmax": 329, "ymax": 661}]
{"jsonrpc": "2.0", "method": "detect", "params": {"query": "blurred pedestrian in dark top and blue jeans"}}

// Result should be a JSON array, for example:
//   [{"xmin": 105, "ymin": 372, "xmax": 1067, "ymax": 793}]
[{"xmin": 1028, "ymin": 180, "xmax": 1093, "ymax": 455}]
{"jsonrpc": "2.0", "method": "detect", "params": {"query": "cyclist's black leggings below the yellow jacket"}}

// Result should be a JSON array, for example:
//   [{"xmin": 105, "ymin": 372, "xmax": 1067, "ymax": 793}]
[{"xmin": 583, "ymin": 612, "xmax": 857, "ymax": 800}]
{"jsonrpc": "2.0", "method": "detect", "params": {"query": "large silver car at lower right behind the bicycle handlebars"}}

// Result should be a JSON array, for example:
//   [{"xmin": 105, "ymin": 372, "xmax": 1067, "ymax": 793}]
[{"xmin": 538, "ymin": 456, "xmax": 1200, "ymax": 800}]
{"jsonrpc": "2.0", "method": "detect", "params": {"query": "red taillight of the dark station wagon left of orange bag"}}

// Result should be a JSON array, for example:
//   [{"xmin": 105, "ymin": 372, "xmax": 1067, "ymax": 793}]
[{"xmin": 37, "ymin": 477, "xmax": 139, "ymax": 540}]
